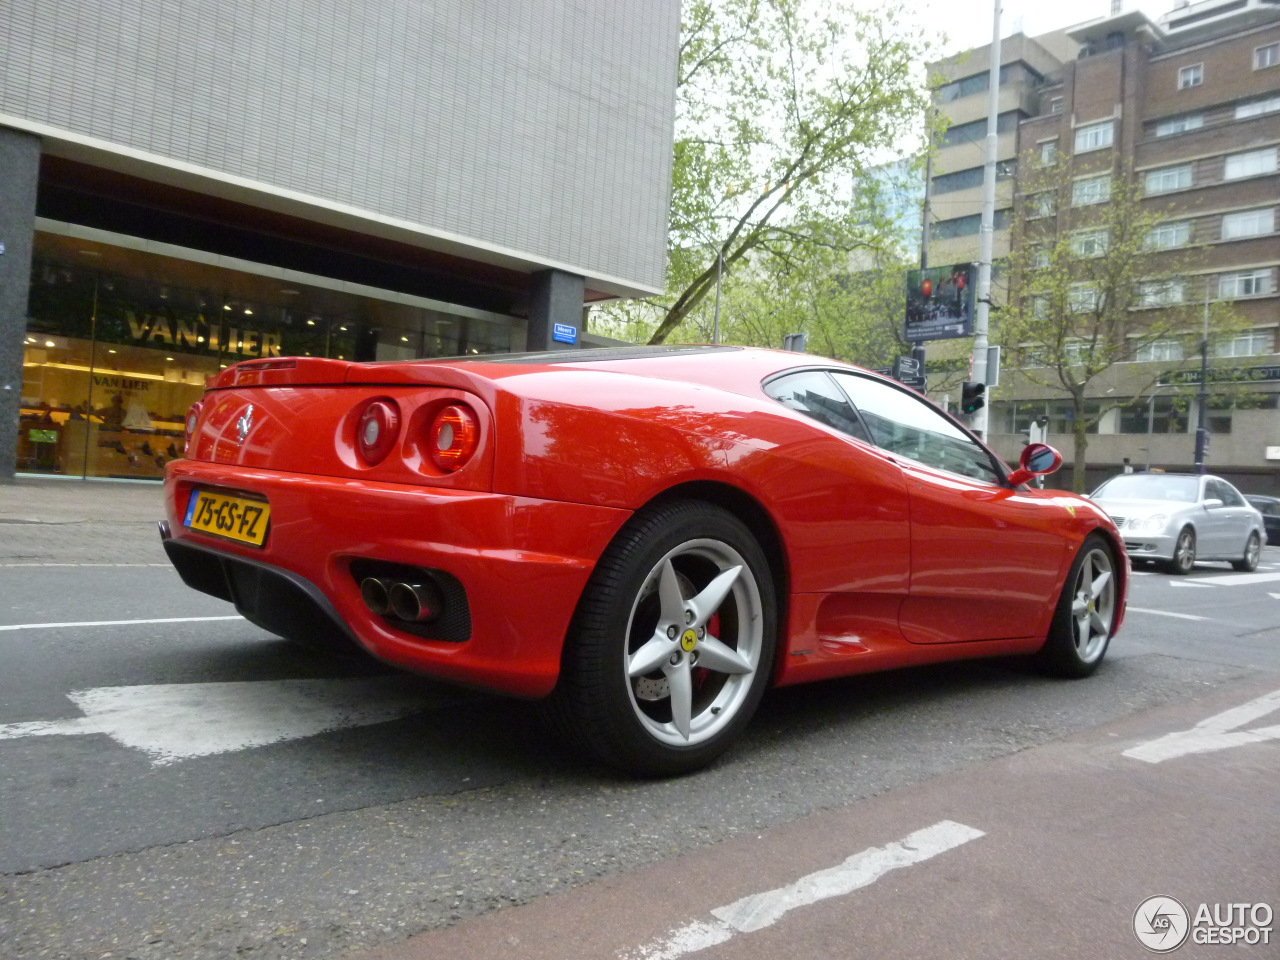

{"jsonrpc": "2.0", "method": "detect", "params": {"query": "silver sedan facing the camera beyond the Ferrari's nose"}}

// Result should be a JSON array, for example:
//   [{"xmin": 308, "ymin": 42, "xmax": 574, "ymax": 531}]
[{"xmin": 1091, "ymin": 474, "xmax": 1266, "ymax": 573}]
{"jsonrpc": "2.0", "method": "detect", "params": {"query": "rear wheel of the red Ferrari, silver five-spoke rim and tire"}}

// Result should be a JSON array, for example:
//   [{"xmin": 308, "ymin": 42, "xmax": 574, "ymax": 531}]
[{"xmin": 544, "ymin": 500, "xmax": 777, "ymax": 777}]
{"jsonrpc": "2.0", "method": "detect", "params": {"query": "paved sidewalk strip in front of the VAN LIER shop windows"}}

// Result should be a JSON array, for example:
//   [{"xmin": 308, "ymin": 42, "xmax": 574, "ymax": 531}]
[{"xmin": 0, "ymin": 476, "xmax": 168, "ymax": 567}]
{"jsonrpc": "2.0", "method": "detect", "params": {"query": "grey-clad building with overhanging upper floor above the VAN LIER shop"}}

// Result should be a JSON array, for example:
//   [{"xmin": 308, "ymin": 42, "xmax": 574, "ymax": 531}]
[{"xmin": 0, "ymin": 0, "xmax": 680, "ymax": 476}]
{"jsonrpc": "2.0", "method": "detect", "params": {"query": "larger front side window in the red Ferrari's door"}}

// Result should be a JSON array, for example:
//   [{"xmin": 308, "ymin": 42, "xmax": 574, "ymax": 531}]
[{"xmin": 832, "ymin": 374, "xmax": 1001, "ymax": 484}]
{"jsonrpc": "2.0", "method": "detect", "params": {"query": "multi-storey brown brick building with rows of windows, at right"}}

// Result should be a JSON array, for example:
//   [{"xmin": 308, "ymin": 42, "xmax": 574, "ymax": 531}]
[{"xmin": 929, "ymin": 0, "xmax": 1280, "ymax": 493}]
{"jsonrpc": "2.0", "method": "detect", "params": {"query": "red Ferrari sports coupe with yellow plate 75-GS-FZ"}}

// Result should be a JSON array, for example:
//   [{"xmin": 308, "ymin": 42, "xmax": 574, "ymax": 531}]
[{"xmin": 161, "ymin": 347, "xmax": 1129, "ymax": 774}]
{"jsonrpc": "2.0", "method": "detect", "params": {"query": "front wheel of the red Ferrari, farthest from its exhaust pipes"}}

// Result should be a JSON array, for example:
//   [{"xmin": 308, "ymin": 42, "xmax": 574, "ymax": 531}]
[{"xmin": 1037, "ymin": 534, "xmax": 1119, "ymax": 677}]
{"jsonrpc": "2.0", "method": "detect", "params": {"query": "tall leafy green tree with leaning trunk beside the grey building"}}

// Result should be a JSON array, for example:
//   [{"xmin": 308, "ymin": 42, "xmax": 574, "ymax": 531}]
[{"xmin": 593, "ymin": 0, "xmax": 927, "ymax": 356}]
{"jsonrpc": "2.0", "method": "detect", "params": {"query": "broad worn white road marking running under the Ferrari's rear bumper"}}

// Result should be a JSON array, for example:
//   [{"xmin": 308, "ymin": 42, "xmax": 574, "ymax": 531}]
[{"xmin": 0, "ymin": 677, "xmax": 468, "ymax": 767}]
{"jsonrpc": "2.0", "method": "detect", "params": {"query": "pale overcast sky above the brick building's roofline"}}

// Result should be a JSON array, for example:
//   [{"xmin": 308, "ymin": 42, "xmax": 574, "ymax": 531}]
[{"xmin": 909, "ymin": 0, "xmax": 1174, "ymax": 52}]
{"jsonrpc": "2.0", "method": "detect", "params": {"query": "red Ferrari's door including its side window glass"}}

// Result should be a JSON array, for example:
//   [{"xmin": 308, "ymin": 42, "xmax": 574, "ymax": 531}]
[{"xmin": 833, "ymin": 372, "xmax": 1069, "ymax": 644}]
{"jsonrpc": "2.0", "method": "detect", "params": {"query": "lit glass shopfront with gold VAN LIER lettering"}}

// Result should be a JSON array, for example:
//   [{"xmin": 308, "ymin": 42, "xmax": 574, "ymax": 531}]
[{"xmin": 18, "ymin": 232, "xmax": 522, "ymax": 479}]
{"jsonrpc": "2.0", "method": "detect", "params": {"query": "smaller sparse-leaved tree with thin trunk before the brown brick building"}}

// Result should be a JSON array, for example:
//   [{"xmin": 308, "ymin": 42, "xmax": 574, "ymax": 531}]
[{"xmin": 996, "ymin": 160, "xmax": 1238, "ymax": 492}]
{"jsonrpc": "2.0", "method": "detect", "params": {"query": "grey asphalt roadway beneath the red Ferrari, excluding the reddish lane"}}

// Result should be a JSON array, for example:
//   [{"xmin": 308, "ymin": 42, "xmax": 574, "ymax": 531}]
[{"xmin": 0, "ymin": 545, "xmax": 1280, "ymax": 960}]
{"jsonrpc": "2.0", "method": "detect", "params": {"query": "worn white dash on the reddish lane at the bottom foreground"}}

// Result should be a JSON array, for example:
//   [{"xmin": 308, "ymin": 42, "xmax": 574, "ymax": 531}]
[{"xmin": 623, "ymin": 820, "xmax": 986, "ymax": 960}]
